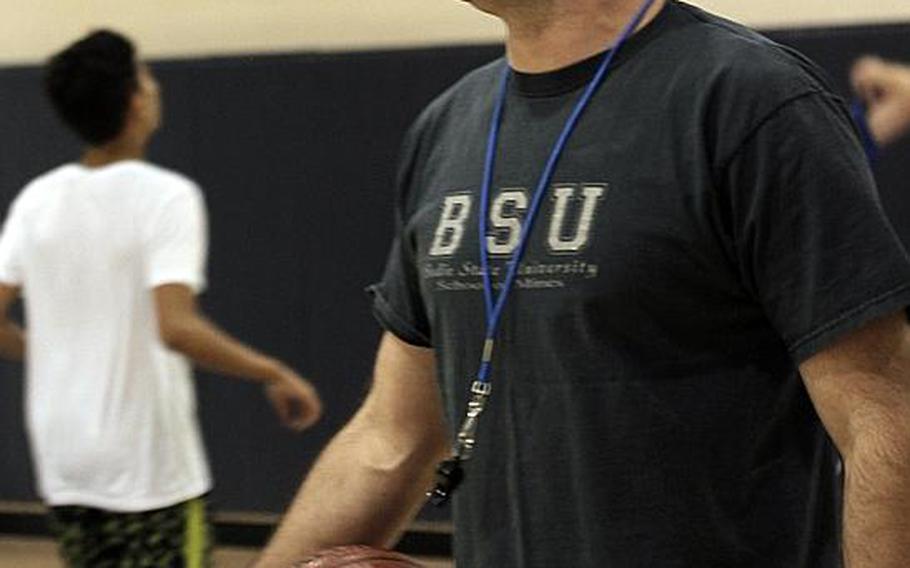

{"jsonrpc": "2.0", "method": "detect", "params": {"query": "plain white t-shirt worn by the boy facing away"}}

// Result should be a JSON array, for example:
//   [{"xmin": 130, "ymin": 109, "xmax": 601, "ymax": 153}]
[{"xmin": 0, "ymin": 161, "xmax": 211, "ymax": 511}]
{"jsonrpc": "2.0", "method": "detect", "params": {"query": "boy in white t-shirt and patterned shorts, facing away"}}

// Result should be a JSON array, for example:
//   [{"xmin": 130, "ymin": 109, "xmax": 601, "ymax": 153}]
[{"xmin": 0, "ymin": 31, "xmax": 321, "ymax": 567}]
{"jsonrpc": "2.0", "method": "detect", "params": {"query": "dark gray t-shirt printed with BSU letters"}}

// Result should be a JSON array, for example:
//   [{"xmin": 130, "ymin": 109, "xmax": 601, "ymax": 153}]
[{"xmin": 374, "ymin": 2, "xmax": 910, "ymax": 568}]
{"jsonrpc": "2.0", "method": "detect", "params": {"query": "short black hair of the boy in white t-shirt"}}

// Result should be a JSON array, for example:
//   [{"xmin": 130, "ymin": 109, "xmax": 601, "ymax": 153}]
[{"xmin": 44, "ymin": 30, "xmax": 138, "ymax": 146}]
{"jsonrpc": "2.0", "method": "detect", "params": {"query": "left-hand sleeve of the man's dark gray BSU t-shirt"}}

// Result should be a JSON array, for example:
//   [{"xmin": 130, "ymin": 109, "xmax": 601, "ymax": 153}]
[{"xmin": 367, "ymin": 122, "xmax": 432, "ymax": 347}]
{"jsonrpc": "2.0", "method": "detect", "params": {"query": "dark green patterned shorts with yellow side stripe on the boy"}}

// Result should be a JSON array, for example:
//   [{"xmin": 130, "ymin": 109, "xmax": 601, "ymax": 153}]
[{"xmin": 50, "ymin": 497, "xmax": 212, "ymax": 568}]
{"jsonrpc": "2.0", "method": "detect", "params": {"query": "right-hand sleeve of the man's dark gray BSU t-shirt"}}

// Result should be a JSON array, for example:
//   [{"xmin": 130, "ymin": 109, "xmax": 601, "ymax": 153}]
[{"xmin": 722, "ymin": 92, "xmax": 910, "ymax": 362}]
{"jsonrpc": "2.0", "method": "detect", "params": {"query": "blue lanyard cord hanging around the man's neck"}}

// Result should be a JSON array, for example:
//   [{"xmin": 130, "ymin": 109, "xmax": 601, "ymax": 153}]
[{"xmin": 472, "ymin": 0, "xmax": 655, "ymax": 388}]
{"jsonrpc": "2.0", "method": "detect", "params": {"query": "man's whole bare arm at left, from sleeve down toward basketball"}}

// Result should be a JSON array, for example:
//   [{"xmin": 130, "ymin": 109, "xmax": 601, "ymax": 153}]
[{"xmin": 257, "ymin": 332, "xmax": 449, "ymax": 568}]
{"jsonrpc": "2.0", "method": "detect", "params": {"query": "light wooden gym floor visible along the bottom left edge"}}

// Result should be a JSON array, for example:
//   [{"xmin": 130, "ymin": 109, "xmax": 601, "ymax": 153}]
[{"xmin": 0, "ymin": 535, "xmax": 454, "ymax": 568}]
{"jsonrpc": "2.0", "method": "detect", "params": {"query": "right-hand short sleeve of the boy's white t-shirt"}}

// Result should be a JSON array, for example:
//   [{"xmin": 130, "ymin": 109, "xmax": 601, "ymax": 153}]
[{"xmin": 145, "ymin": 184, "xmax": 208, "ymax": 293}]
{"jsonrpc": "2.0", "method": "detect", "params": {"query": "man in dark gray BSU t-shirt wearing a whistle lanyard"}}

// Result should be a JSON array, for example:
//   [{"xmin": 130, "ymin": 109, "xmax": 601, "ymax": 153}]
[{"xmin": 256, "ymin": 0, "xmax": 910, "ymax": 568}]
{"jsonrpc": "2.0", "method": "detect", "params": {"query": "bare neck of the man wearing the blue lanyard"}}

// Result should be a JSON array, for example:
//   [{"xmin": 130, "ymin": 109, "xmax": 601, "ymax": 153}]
[{"xmin": 501, "ymin": 0, "xmax": 667, "ymax": 73}]
